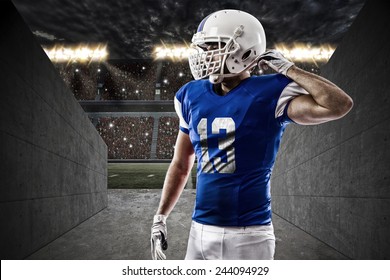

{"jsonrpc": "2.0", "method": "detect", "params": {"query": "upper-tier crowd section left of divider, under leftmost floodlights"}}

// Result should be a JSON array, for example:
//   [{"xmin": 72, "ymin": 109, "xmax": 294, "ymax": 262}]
[{"xmin": 55, "ymin": 60, "xmax": 163, "ymax": 100}]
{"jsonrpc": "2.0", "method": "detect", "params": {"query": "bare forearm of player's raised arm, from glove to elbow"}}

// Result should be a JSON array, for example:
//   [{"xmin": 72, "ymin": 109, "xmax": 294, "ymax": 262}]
[{"xmin": 287, "ymin": 66, "xmax": 353, "ymax": 117}]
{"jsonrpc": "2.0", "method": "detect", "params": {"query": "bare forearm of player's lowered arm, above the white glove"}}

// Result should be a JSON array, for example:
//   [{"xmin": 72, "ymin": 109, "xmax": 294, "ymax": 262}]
[{"xmin": 157, "ymin": 160, "xmax": 193, "ymax": 216}]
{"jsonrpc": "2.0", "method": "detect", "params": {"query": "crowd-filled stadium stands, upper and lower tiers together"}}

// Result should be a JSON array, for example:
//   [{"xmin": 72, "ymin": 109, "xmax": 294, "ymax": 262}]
[{"xmin": 55, "ymin": 60, "xmax": 319, "ymax": 160}]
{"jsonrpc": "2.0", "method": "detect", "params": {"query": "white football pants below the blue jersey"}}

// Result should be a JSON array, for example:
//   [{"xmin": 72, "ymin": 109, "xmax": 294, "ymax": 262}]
[{"xmin": 185, "ymin": 221, "xmax": 275, "ymax": 260}]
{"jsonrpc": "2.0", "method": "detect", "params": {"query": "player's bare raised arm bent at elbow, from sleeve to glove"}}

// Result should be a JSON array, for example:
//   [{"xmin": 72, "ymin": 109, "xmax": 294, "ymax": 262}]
[{"xmin": 287, "ymin": 66, "xmax": 353, "ymax": 125}]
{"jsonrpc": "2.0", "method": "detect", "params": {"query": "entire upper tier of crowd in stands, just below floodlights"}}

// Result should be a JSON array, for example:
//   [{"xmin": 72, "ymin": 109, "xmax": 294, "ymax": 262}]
[{"xmin": 55, "ymin": 60, "xmax": 319, "ymax": 100}]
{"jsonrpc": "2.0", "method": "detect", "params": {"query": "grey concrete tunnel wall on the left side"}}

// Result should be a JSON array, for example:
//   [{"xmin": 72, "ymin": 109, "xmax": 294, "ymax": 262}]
[{"xmin": 0, "ymin": 1, "xmax": 107, "ymax": 259}]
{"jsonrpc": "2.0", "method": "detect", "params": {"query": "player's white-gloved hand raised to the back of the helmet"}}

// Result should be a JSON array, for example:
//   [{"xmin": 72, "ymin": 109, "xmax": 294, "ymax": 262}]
[{"xmin": 259, "ymin": 50, "xmax": 294, "ymax": 76}]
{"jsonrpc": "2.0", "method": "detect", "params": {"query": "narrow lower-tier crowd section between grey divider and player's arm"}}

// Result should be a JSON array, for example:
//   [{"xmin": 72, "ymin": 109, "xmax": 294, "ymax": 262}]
[{"xmin": 156, "ymin": 117, "xmax": 179, "ymax": 159}]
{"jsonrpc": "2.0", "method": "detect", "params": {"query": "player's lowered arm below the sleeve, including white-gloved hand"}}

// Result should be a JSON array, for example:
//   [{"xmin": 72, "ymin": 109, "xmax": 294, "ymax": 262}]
[{"xmin": 150, "ymin": 130, "xmax": 195, "ymax": 260}]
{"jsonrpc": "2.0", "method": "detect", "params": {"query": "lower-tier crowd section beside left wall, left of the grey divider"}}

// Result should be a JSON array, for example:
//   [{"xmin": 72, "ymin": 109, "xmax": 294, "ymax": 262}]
[{"xmin": 95, "ymin": 116, "xmax": 154, "ymax": 159}]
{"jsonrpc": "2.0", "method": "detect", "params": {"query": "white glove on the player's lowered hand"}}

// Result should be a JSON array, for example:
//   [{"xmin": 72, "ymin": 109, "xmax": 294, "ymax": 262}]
[{"xmin": 150, "ymin": 215, "xmax": 168, "ymax": 260}]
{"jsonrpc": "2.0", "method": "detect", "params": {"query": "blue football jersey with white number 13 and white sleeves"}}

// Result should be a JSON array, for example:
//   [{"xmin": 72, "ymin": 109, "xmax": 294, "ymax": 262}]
[{"xmin": 175, "ymin": 74, "xmax": 306, "ymax": 226}]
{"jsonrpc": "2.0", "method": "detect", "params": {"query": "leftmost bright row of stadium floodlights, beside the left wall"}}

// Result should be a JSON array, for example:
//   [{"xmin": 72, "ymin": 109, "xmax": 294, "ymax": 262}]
[{"xmin": 43, "ymin": 44, "xmax": 108, "ymax": 63}]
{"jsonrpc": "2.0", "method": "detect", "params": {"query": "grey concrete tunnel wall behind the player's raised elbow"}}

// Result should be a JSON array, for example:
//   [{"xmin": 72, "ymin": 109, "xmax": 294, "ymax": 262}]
[{"xmin": 272, "ymin": 1, "xmax": 390, "ymax": 259}]
